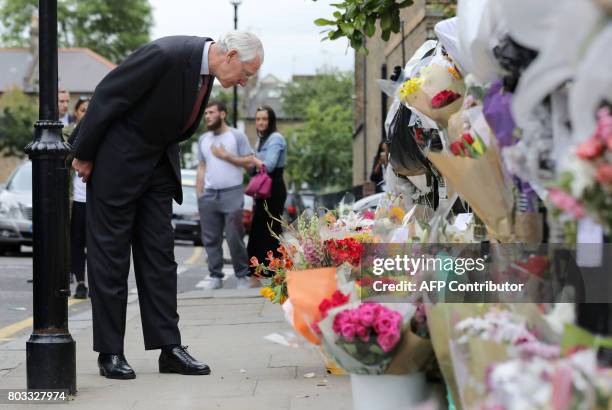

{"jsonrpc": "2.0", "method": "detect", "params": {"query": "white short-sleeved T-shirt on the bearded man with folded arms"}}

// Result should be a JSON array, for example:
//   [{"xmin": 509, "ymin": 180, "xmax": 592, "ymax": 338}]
[{"xmin": 198, "ymin": 128, "xmax": 253, "ymax": 189}]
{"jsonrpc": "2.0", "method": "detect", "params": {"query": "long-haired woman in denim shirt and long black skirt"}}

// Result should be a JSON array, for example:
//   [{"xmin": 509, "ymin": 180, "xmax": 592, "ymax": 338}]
[{"xmin": 247, "ymin": 106, "xmax": 287, "ymax": 274}]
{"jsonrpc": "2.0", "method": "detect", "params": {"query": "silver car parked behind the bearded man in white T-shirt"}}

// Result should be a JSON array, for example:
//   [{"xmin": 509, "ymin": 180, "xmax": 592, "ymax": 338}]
[{"xmin": 172, "ymin": 169, "xmax": 253, "ymax": 246}]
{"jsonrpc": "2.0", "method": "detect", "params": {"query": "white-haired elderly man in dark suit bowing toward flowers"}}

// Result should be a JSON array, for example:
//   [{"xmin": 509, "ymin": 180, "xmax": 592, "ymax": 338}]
[{"xmin": 72, "ymin": 32, "xmax": 264, "ymax": 379}]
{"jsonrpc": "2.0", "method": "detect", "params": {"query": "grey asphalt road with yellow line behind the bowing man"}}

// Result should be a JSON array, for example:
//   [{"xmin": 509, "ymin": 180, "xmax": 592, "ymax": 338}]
[{"xmin": 0, "ymin": 243, "xmax": 235, "ymax": 344}]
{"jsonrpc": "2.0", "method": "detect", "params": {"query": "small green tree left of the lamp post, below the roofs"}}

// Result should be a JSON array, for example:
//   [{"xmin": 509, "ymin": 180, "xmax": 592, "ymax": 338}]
[{"xmin": 0, "ymin": 88, "xmax": 38, "ymax": 157}]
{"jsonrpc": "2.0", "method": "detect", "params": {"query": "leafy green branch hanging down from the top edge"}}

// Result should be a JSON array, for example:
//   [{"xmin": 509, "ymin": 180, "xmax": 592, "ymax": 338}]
[{"xmin": 315, "ymin": 0, "xmax": 413, "ymax": 54}]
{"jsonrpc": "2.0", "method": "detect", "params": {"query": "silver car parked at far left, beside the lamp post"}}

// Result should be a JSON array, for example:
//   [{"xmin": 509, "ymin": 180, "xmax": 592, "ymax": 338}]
[{"xmin": 0, "ymin": 161, "xmax": 32, "ymax": 253}]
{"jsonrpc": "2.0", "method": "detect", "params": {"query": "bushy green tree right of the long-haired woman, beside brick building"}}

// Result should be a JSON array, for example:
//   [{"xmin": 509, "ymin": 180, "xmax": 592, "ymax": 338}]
[{"xmin": 283, "ymin": 72, "xmax": 353, "ymax": 190}]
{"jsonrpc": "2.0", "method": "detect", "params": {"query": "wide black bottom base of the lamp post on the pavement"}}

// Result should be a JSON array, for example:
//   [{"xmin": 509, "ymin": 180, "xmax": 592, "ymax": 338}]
[{"xmin": 26, "ymin": 334, "xmax": 76, "ymax": 395}]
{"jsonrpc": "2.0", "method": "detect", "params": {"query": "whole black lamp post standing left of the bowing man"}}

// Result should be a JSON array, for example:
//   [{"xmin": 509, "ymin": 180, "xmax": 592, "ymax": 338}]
[{"xmin": 25, "ymin": 0, "xmax": 76, "ymax": 394}]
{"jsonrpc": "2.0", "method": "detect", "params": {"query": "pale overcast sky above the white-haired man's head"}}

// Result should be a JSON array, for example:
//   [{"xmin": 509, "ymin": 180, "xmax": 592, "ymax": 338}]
[{"xmin": 150, "ymin": 0, "xmax": 354, "ymax": 81}]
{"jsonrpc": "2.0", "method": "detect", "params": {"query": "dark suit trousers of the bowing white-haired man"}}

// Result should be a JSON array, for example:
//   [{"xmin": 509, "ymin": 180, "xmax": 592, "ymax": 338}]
[{"xmin": 87, "ymin": 155, "xmax": 181, "ymax": 354}]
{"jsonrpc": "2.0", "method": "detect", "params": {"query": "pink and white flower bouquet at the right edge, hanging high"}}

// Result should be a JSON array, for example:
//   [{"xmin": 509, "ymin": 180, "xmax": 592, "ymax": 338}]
[{"xmin": 548, "ymin": 107, "xmax": 612, "ymax": 232}]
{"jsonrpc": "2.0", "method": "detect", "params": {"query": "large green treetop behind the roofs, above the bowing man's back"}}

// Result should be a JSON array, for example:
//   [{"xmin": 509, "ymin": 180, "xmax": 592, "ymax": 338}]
[{"xmin": 0, "ymin": 0, "xmax": 153, "ymax": 63}]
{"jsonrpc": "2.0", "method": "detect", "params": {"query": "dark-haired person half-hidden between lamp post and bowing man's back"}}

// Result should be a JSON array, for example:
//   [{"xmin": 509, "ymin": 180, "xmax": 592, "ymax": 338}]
[{"xmin": 62, "ymin": 97, "xmax": 89, "ymax": 299}]
